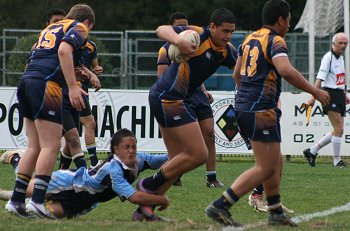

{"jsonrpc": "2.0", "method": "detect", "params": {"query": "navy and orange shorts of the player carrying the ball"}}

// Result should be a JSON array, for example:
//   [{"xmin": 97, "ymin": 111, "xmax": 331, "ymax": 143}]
[{"xmin": 148, "ymin": 95, "xmax": 197, "ymax": 128}]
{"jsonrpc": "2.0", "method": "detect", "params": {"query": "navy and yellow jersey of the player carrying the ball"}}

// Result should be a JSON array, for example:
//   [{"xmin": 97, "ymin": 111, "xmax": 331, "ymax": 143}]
[{"xmin": 150, "ymin": 26, "xmax": 237, "ymax": 100}]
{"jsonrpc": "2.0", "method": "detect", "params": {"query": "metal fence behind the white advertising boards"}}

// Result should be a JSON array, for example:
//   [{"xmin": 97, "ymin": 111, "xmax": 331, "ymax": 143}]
[{"xmin": 0, "ymin": 29, "xmax": 331, "ymax": 92}]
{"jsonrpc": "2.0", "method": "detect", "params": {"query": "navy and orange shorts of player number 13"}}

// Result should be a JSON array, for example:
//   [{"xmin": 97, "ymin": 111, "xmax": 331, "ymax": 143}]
[{"xmin": 236, "ymin": 108, "xmax": 281, "ymax": 142}]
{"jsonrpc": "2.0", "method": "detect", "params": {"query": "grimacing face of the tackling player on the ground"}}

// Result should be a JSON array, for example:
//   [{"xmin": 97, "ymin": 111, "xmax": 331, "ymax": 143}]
[{"xmin": 113, "ymin": 137, "xmax": 137, "ymax": 167}]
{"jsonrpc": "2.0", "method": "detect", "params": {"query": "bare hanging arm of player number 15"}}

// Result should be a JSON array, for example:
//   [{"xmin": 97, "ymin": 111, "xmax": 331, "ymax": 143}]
[{"xmin": 58, "ymin": 42, "xmax": 87, "ymax": 111}]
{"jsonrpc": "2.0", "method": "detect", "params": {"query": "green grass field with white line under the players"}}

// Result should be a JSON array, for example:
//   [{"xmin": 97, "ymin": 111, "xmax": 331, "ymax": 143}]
[{"xmin": 0, "ymin": 156, "xmax": 350, "ymax": 231}]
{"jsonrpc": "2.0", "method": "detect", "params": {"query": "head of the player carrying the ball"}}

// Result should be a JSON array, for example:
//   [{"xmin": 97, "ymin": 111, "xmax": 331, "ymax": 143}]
[{"xmin": 209, "ymin": 8, "xmax": 236, "ymax": 47}]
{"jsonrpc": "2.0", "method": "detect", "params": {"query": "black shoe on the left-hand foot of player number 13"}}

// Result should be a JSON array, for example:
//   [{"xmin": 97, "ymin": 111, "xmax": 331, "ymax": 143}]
[{"xmin": 205, "ymin": 203, "xmax": 243, "ymax": 227}]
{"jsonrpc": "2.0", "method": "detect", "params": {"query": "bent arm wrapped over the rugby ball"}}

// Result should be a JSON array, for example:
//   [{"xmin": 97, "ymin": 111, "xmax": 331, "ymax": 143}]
[{"xmin": 156, "ymin": 25, "xmax": 197, "ymax": 56}]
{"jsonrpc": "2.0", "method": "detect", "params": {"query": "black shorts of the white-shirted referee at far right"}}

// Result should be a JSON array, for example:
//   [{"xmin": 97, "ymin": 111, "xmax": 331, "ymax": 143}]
[{"xmin": 322, "ymin": 88, "xmax": 346, "ymax": 117}]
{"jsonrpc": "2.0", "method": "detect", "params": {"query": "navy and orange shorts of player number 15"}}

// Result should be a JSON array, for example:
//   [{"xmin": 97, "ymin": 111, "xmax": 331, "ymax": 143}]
[{"xmin": 17, "ymin": 78, "xmax": 63, "ymax": 124}]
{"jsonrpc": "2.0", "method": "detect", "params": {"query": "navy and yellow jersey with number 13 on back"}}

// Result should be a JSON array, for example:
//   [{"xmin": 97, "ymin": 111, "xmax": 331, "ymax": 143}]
[{"xmin": 235, "ymin": 27, "xmax": 288, "ymax": 111}]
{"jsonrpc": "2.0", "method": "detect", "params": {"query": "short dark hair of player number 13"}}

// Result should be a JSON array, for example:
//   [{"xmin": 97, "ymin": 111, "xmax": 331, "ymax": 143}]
[{"xmin": 262, "ymin": 0, "xmax": 290, "ymax": 25}]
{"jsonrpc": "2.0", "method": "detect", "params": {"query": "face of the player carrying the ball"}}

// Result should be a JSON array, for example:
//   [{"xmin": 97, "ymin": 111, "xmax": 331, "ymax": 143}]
[{"xmin": 209, "ymin": 22, "xmax": 236, "ymax": 47}]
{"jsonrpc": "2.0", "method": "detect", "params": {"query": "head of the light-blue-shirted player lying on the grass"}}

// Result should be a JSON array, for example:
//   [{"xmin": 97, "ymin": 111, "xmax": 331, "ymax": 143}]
[{"xmin": 111, "ymin": 128, "xmax": 137, "ymax": 167}]
